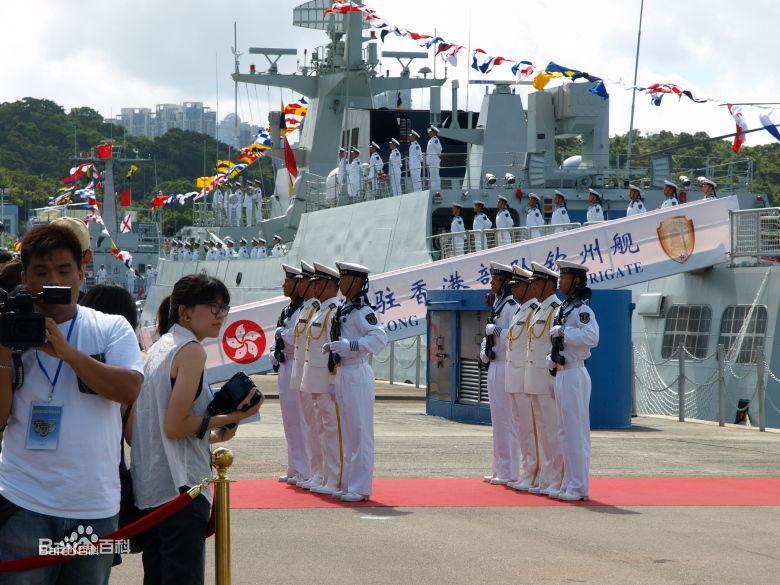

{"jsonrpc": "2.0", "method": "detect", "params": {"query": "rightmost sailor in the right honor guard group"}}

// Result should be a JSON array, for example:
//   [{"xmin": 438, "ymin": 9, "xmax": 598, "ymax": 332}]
[{"xmin": 547, "ymin": 260, "xmax": 599, "ymax": 501}]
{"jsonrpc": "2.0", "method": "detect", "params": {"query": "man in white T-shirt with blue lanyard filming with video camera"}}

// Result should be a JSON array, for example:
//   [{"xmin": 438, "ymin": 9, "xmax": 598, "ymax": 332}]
[{"xmin": 0, "ymin": 224, "xmax": 143, "ymax": 584}]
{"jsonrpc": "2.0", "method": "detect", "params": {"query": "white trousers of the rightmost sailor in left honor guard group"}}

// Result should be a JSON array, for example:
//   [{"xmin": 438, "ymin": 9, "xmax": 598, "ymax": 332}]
[{"xmin": 336, "ymin": 360, "xmax": 374, "ymax": 496}]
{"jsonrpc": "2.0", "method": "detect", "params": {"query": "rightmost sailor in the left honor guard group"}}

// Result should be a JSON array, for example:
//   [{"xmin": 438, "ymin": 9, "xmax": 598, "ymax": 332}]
[{"xmin": 324, "ymin": 262, "xmax": 387, "ymax": 502}]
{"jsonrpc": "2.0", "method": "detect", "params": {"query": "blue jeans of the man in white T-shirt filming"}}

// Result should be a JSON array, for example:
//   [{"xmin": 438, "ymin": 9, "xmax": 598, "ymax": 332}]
[{"xmin": 0, "ymin": 508, "xmax": 118, "ymax": 585}]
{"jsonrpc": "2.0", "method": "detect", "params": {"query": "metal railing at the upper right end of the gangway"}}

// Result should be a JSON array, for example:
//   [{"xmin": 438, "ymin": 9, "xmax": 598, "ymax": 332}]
[{"xmin": 731, "ymin": 207, "xmax": 780, "ymax": 259}]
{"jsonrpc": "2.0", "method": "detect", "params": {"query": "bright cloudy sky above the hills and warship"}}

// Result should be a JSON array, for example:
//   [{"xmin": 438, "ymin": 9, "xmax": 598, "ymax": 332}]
[{"xmin": 0, "ymin": 0, "xmax": 780, "ymax": 144}]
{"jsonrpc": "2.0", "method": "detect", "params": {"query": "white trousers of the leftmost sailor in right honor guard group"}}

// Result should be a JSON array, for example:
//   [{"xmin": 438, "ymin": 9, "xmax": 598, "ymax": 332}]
[{"xmin": 487, "ymin": 361, "xmax": 520, "ymax": 481}]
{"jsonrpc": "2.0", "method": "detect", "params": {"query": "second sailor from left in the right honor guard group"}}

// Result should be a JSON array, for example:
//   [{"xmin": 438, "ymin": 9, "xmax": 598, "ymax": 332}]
[{"xmin": 503, "ymin": 265, "xmax": 539, "ymax": 491}]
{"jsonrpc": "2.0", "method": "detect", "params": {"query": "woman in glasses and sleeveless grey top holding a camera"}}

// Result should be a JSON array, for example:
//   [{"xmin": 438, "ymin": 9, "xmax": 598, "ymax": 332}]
[{"xmin": 131, "ymin": 274, "xmax": 262, "ymax": 584}]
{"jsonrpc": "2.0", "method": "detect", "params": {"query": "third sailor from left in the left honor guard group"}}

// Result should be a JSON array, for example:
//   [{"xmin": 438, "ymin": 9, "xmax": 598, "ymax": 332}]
[{"xmin": 301, "ymin": 262, "xmax": 341, "ymax": 495}]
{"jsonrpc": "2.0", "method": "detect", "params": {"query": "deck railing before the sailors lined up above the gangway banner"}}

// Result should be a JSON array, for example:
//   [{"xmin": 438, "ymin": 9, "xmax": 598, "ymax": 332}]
[{"xmin": 428, "ymin": 223, "xmax": 582, "ymax": 260}]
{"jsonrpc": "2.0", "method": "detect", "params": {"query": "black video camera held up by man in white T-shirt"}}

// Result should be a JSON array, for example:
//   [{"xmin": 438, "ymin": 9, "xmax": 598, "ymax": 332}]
[{"xmin": 0, "ymin": 285, "xmax": 71, "ymax": 351}]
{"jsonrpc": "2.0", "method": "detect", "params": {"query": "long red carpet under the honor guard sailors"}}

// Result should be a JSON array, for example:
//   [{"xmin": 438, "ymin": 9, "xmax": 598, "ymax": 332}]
[{"xmin": 230, "ymin": 477, "xmax": 780, "ymax": 510}]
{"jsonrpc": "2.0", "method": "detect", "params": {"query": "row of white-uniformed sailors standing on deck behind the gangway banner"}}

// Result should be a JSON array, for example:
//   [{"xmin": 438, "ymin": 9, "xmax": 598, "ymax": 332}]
[{"xmin": 450, "ymin": 177, "xmax": 717, "ymax": 255}]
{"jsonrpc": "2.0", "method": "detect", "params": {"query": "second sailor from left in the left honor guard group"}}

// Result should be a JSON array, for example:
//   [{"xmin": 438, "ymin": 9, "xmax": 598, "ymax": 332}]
[{"xmin": 284, "ymin": 262, "xmax": 322, "ymax": 489}]
